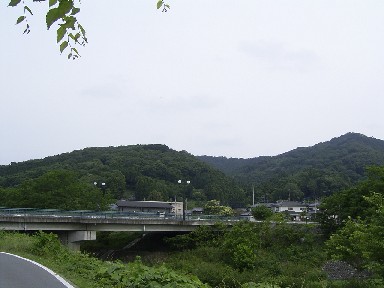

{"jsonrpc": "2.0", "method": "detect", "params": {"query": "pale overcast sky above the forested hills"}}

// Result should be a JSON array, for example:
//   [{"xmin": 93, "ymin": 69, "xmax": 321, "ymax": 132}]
[{"xmin": 0, "ymin": 0, "xmax": 384, "ymax": 165}]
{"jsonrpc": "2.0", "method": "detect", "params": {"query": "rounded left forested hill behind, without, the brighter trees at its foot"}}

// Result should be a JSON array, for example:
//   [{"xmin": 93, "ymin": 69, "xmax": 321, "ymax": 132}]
[{"xmin": 0, "ymin": 144, "xmax": 249, "ymax": 208}]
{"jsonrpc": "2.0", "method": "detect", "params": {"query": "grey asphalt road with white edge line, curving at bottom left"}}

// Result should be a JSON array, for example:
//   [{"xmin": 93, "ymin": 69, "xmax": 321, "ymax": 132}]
[{"xmin": 0, "ymin": 252, "xmax": 74, "ymax": 288}]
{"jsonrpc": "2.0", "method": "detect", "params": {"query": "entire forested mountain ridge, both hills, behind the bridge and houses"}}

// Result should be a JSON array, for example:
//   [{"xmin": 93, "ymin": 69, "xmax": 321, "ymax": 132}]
[{"xmin": 0, "ymin": 133, "xmax": 384, "ymax": 207}]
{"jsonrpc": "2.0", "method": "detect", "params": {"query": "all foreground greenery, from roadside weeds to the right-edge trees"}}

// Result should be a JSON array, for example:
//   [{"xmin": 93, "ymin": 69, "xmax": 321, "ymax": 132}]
[{"xmin": 0, "ymin": 167, "xmax": 384, "ymax": 288}]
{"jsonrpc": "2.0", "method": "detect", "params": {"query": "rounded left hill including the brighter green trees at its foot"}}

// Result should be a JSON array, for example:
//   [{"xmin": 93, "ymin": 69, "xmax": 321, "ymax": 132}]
[{"xmin": 0, "ymin": 145, "xmax": 247, "ymax": 210}]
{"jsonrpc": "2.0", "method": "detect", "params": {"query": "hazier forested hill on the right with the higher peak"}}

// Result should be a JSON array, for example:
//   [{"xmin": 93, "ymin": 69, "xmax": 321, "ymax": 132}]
[{"xmin": 199, "ymin": 133, "xmax": 384, "ymax": 200}]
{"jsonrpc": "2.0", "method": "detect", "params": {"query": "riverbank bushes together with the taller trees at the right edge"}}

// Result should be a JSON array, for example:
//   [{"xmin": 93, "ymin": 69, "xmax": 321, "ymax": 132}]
[{"xmin": 163, "ymin": 167, "xmax": 384, "ymax": 288}]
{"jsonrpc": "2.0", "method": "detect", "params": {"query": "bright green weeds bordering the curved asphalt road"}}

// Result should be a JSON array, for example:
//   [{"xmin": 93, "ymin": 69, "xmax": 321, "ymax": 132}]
[{"xmin": 0, "ymin": 231, "xmax": 209, "ymax": 288}]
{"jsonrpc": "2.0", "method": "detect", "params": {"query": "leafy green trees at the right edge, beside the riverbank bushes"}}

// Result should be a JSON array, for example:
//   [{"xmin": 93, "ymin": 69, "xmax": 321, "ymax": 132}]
[{"xmin": 322, "ymin": 167, "xmax": 384, "ymax": 287}]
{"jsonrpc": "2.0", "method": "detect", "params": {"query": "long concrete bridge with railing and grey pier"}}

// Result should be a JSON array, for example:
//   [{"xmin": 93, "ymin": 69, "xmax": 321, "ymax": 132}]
[{"xmin": 0, "ymin": 209, "xmax": 240, "ymax": 250}]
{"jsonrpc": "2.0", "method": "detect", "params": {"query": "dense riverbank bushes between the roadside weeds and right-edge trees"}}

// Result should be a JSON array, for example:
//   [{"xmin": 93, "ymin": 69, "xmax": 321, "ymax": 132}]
[{"xmin": 166, "ymin": 222, "xmax": 325, "ymax": 288}]
